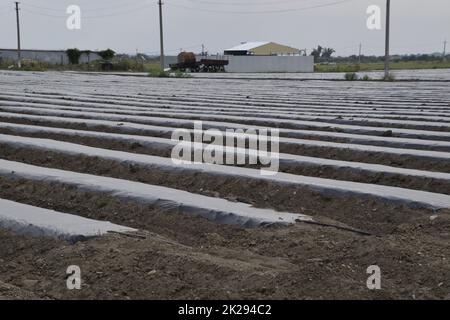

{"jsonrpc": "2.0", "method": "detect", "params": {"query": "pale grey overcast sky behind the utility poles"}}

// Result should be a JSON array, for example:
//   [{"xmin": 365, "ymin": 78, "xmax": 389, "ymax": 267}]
[{"xmin": 0, "ymin": 0, "xmax": 450, "ymax": 55}]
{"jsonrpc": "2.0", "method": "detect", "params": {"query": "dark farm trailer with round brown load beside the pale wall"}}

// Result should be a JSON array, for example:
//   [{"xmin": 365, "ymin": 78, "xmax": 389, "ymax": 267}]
[{"xmin": 170, "ymin": 52, "xmax": 228, "ymax": 72}]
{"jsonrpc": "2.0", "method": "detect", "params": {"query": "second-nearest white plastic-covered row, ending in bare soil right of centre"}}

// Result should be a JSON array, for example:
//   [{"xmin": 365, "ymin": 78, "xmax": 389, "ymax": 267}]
[{"xmin": 0, "ymin": 160, "xmax": 313, "ymax": 228}]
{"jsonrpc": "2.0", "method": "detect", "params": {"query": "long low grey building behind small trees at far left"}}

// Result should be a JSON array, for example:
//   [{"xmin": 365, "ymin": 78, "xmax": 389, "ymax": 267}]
[{"xmin": 0, "ymin": 49, "xmax": 102, "ymax": 65}]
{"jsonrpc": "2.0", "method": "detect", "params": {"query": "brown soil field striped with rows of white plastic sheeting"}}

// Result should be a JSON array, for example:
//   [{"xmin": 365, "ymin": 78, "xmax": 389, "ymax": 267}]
[{"xmin": 0, "ymin": 70, "xmax": 450, "ymax": 299}]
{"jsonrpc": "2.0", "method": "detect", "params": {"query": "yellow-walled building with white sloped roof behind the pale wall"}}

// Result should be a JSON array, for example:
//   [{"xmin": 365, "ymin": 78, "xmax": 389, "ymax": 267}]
[{"xmin": 224, "ymin": 42, "xmax": 300, "ymax": 56}]
